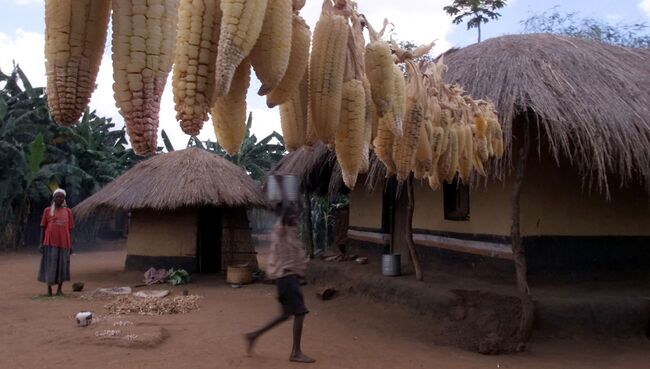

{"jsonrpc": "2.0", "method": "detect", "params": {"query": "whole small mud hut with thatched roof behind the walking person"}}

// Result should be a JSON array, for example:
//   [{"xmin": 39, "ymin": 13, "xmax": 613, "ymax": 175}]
[{"xmin": 73, "ymin": 148, "xmax": 265, "ymax": 273}]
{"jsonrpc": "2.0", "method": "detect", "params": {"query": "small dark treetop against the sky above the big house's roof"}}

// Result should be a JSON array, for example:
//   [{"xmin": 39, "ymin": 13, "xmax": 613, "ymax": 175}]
[{"xmin": 443, "ymin": 0, "xmax": 506, "ymax": 42}]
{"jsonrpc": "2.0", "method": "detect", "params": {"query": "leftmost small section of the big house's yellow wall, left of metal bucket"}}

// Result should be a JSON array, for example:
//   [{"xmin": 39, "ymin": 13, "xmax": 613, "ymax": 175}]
[{"xmin": 349, "ymin": 185, "xmax": 383, "ymax": 229}]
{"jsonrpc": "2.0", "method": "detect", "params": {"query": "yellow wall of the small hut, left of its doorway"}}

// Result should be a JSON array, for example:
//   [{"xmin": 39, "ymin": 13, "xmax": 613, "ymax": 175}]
[{"xmin": 126, "ymin": 209, "xmax": 197, "ymax": 256}]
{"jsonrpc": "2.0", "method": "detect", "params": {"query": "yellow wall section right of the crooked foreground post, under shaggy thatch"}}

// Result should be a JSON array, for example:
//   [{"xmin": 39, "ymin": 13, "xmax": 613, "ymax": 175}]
[{"xmin": 521, "ymin": 158, "xmax": 650, "ymax": 236}]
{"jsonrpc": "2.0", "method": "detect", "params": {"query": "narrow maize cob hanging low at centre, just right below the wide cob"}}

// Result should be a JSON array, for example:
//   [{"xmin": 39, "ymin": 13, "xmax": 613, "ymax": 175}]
[{"xmin": 335, "ymin": 79, "xmax": 367, "ymax": 190}]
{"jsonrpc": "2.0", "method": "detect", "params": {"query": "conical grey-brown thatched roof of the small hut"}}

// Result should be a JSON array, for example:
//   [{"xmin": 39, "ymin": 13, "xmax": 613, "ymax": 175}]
[{"xmin": 73, "ymin": 148, "xmax": 266, "ymax": 219}]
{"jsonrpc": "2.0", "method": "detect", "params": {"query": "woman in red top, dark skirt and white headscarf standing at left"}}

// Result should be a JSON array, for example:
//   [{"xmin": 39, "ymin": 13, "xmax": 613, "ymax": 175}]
[{"xmin": 38, "ymin": 188, "xmax": 74, "ymax": 296}]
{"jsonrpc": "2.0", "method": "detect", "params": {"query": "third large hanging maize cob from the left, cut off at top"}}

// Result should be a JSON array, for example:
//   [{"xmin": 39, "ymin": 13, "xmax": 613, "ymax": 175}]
[{"xmin": 172, "ymin": 0, "xmax": 221, "ymax": 136}]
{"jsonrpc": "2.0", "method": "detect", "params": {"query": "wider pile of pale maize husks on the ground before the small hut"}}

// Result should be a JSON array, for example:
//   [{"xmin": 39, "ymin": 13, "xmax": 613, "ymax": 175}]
[{"xmin": 104, "ymin": 295, "xmax": 201, "ymax": 315}]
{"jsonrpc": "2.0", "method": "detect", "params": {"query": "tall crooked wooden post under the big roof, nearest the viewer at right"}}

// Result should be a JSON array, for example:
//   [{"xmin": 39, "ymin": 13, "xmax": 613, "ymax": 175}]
[{"xmin": 510, "ymin": 126, "xmax": 534, "ymax": 348}]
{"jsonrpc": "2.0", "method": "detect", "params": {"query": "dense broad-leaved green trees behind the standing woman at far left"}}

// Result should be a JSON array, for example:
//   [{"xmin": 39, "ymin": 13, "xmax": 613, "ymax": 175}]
[{"xmin": 0, "ymin": 66, "xmax": 141, "ymax": 248}]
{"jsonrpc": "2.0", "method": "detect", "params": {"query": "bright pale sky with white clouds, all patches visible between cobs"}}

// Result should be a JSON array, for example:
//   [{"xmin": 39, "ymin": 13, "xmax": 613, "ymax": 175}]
[{"xmin": 0, "ymin": 0, "xmax": 650, "ymax": 149}]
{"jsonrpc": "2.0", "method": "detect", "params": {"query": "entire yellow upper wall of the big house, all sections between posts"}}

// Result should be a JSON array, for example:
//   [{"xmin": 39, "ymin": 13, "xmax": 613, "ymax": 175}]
[{"xmin": 350, "ymin": 152, "xmax": 650, "ymax": 236}]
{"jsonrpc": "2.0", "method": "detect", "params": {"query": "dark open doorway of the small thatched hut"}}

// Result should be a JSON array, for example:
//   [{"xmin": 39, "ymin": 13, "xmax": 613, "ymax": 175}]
[{"xmin": 196, "ymin": 207, "xmax": 221, "ymax": 273}]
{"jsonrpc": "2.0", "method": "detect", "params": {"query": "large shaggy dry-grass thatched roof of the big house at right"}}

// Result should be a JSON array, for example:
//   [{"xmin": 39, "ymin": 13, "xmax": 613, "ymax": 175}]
[{"xmin": 444, "ymin": 34, "xmax": 650, "ymax": 193}]
